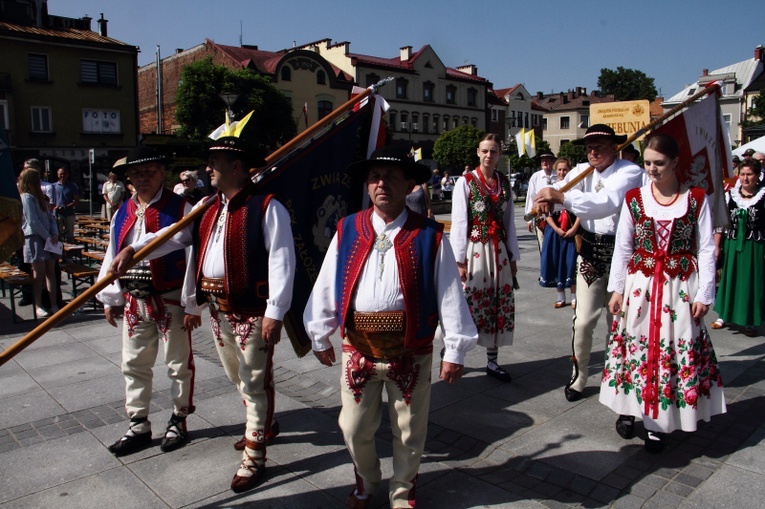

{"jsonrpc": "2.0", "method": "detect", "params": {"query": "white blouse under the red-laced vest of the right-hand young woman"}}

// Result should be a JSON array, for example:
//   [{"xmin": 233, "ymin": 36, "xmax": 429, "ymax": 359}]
[{"xmin": 608, "ymin": 184, "xmax": 715, "ymax": 305}]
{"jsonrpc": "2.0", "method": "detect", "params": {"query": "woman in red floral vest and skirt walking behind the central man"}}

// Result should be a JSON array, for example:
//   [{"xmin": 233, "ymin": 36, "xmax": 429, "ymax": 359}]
[{"xmin": 450, "ymin": 134, "xmax": 520, "ymax": 382}]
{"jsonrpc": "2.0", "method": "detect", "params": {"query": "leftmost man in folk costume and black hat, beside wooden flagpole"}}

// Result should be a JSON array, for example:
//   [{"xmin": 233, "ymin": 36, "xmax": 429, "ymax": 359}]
[{"xmin": 97, "ymin": 146, "xmax": 201, "ymax": 456}]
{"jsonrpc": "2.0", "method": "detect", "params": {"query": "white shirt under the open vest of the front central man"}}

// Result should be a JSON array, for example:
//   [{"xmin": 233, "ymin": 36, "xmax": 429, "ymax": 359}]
[{"xmin": 303, "ymin": 209, "xmax": 478, "ymax": 365}]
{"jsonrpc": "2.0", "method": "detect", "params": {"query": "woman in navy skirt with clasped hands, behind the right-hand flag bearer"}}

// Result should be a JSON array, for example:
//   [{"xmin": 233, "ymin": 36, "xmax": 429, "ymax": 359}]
[{"xmin": 539, "ymin": 157, "xmax": 581, "ymax": 309}]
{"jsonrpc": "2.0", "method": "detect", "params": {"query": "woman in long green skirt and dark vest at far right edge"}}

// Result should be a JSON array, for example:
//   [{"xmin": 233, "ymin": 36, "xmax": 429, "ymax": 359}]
[{"xmin": 711, "ymin": 158, "xmax": 765, "ymax": 336}]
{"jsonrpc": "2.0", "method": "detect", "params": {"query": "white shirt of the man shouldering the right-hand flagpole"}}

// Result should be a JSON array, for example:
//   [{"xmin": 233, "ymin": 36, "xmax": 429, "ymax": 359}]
[{"xmin": 554, "ymin": 158, "xmax": 645, "ymax": 235}]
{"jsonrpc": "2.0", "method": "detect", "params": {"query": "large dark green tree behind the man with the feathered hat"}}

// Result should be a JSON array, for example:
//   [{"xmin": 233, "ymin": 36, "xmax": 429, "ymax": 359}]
[{"xmin": 175, "ymin": 57, "xmax": 297, "ymax": 152}]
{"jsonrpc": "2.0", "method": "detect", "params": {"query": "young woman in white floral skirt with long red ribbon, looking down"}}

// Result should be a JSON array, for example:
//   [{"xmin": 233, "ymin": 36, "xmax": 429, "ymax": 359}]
[{"xmin": 600, "ymin": 134, "xmax": 726, "ymax": 452}]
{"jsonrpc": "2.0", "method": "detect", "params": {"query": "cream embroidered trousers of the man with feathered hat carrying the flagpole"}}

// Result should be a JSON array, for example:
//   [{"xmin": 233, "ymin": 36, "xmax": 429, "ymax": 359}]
[{"xmin": 210, "ymin": 305, "xmax": 274, "ymax": 451}]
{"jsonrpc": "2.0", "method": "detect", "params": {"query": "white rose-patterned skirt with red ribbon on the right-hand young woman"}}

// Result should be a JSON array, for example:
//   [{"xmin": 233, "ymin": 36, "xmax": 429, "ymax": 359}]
[{"xmin": 600, "ymin": 272, "xmax": 726, "ymax": 433}]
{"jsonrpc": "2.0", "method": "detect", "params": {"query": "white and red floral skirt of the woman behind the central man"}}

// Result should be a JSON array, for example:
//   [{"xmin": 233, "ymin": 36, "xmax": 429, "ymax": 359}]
[{"xmin": 464, "ymin": 241, "xmax": 515, "ymax": 348}]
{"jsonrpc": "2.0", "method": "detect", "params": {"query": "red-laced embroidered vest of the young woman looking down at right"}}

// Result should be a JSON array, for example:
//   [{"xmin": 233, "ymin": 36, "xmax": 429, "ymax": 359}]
[{"xmin": 626, "ymin": 187, "xmax": 704, "ymax": 280}]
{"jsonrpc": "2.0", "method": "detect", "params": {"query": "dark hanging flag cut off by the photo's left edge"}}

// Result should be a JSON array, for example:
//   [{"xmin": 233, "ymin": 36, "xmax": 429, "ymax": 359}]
[{"xmin": 0, "ymin": 129, "xmax": 24, "ymax": 261}]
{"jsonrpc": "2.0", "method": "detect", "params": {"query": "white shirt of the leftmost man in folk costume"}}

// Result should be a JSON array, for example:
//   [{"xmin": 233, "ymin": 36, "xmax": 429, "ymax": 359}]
[{"xmin": 96, "ymin": 188, "xmax": 202, "ymax": 315}]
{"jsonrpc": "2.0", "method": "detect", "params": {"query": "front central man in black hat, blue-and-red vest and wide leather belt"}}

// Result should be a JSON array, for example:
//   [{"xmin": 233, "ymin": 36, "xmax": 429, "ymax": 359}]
[{"xmin": 303, "ymin": 147, "xmax": 478, "ymax": 508}]
